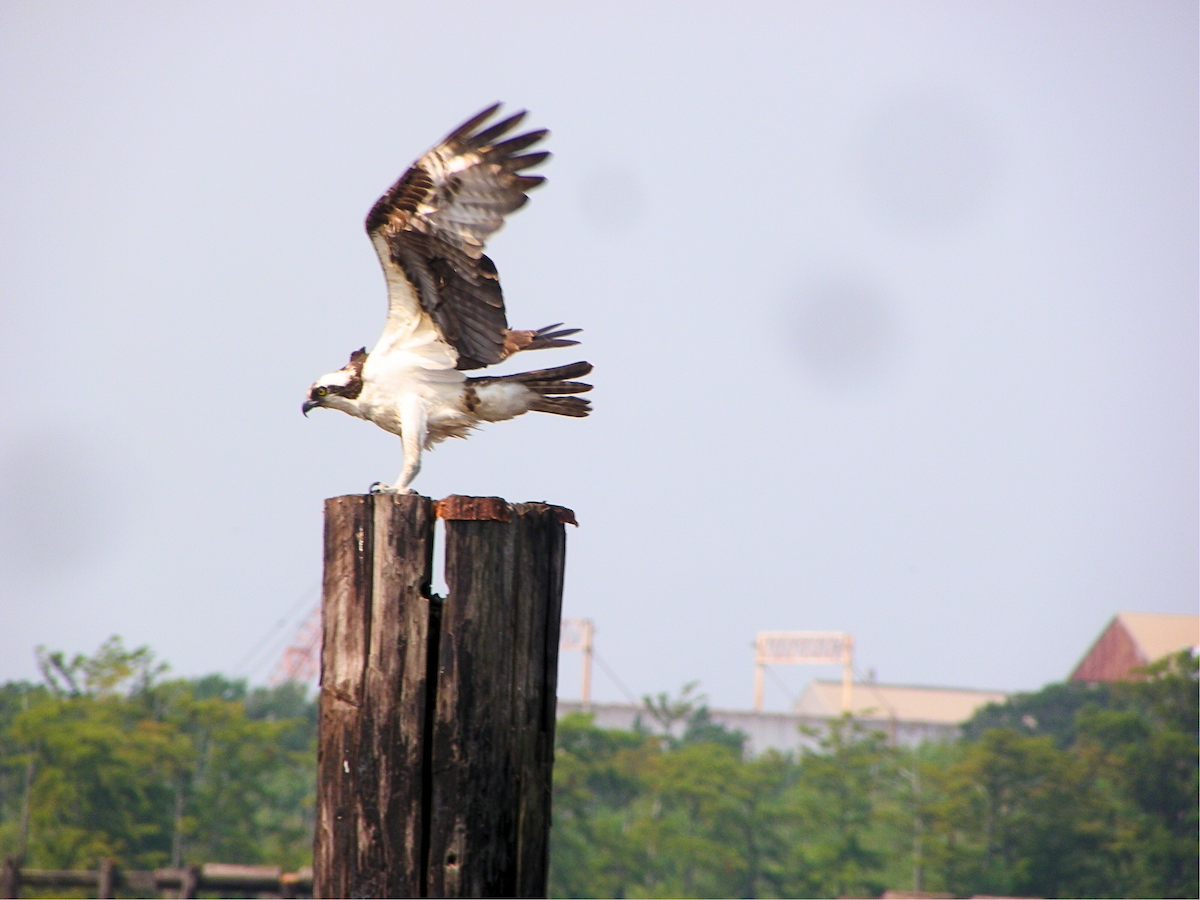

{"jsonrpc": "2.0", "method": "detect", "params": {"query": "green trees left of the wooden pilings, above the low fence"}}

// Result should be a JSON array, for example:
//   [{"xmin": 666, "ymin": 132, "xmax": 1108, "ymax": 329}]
[{"xmin": 0, "ymin": 637, "xmax": 316, "ymax": 869}]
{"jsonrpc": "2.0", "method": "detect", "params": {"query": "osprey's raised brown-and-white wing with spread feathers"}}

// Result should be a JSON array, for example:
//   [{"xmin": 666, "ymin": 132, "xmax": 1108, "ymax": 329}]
[{"xmin": 366, "ymin": 103, "xmax": 550, "ymax": 368}]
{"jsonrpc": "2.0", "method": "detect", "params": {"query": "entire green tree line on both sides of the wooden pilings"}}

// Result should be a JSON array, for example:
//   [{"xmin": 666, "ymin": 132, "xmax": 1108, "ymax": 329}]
[{"xmin": 0, "ymin": 638, "xmax": 1200, "ymax": 898}]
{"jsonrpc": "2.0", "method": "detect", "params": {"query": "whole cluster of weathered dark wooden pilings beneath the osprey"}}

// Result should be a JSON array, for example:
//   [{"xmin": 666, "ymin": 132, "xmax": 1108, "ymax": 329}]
[{"xmin": 313, "ymin": 494, "xmax": 574, "ymax": 898}]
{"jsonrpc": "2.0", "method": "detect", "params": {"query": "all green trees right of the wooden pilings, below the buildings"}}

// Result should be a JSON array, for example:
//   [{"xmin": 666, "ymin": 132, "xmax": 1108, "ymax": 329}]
[{"xmin": 550, "ymin": 667, "xmax": 1200, "ymax": 896}]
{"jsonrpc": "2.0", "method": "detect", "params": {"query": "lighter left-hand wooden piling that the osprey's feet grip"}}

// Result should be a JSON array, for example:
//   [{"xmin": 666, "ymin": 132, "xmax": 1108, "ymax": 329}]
[{"xmin": 313, "ymin": 494, "xmax": 433, "ymax": 896}]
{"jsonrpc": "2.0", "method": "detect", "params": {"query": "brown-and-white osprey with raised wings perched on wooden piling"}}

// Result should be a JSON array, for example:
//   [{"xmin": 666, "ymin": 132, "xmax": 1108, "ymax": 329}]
[{"xmin": 302, "ymin": 109, "xmax": 592, "ymax": 493}]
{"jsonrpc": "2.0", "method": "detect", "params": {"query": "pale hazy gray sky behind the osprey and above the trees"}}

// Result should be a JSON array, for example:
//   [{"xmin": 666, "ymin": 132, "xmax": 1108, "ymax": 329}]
[{"xmin": 0, "ymin": 0, "xmax": 1200, "ymax": 708}]
